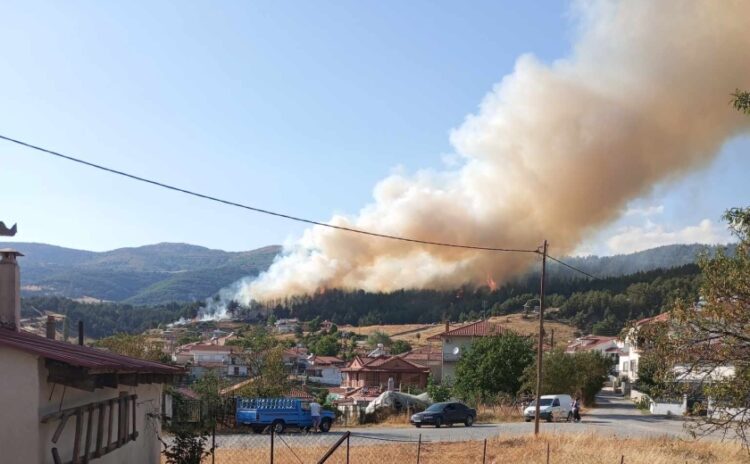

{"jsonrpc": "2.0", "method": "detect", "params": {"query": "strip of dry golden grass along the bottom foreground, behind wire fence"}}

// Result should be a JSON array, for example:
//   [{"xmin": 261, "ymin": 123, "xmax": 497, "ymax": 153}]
[{"xmin": 201, "ymin": 434, "xmax": 749, "ymax": 464}]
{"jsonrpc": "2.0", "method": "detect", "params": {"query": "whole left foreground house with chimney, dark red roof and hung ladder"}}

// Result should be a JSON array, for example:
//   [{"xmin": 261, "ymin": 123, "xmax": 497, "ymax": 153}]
[{"xmin": 0, "ymin": 249, "xmax": 182, "ymax": 464}]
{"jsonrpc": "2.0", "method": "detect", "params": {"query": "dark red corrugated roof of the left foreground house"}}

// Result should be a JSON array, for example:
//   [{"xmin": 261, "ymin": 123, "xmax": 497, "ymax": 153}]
[{"xmin": 0, "ymin": 328, "xmax": 183, "ymax": 374}]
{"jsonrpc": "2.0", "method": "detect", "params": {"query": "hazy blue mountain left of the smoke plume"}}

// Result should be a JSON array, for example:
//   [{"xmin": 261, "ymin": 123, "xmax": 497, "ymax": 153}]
[{"xmin": 0, "ymin": 242, "xmax": 281, "ymax": 305}]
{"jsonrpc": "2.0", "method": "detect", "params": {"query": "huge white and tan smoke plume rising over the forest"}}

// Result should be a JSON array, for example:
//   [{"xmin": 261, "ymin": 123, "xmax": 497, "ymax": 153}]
[{"xmin": 216, "ymin": 0, "xmax": 750, "ymax": 312}]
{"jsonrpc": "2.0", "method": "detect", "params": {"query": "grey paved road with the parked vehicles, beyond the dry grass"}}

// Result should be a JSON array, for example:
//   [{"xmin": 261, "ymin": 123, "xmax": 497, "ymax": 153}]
[{"xmin": 216, "ymin": 393, "xmax": 689, "ymax": 447}]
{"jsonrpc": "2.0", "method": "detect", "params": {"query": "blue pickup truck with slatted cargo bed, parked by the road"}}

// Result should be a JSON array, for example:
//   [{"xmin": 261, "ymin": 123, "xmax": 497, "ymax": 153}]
[{"xmin": 235, "ymin": 398, "xmax": 336, "ymax": 433}]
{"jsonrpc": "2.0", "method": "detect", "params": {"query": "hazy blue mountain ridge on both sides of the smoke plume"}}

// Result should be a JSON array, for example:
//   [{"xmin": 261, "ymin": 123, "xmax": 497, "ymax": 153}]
[{"xmin": 0, "ymin": 242, "xmax": 731, "ymax": 305}]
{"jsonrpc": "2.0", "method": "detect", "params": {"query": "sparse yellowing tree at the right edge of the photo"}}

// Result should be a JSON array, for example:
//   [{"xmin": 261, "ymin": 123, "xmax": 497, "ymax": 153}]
[{"xmin": 639, "ymin": 208, "xmax": 750, "ymax": 451}]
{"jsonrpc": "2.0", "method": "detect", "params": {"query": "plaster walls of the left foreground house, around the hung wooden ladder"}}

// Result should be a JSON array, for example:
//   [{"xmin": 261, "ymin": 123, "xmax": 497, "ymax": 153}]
[{"xmin": 0, "ymin": 347, "xmax": 162, "ymax": 464}]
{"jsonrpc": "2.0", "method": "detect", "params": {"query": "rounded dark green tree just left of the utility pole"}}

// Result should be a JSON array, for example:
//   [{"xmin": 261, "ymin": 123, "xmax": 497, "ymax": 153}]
[{"xmin": 454, "ymin": 332, "xmax": 534, "ymax": 400}]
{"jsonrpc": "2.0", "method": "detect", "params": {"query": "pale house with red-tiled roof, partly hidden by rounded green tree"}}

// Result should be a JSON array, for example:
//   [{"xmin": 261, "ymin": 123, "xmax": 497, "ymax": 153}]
[{"xmin": 427, "ymin": 320, "xmax": 505, "ymax": 382}]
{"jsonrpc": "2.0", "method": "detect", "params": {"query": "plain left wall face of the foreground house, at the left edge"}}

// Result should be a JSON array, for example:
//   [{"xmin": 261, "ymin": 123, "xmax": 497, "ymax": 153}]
[{"xmin": 0, "ymin": 347, "xmax": 41, "ymax": 464}]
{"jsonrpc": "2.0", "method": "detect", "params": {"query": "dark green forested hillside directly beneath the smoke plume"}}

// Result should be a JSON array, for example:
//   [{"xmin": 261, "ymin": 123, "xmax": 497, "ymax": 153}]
[{"xmin": 248, "ymin": 264, "xmax": 700, "ymax": 334}]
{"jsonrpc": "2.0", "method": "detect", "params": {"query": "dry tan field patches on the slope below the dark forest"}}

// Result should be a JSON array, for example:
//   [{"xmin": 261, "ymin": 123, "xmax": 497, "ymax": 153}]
[{"xmin": 340, "ymin": 314, "xmax": 576, "ymax": 347}]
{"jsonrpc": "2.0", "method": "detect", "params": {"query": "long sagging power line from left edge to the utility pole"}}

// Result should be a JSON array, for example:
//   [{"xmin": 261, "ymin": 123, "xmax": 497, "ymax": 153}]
[{"xmin": 0, "ymin": 135, "xmax": 539, "ymax": 254}]
